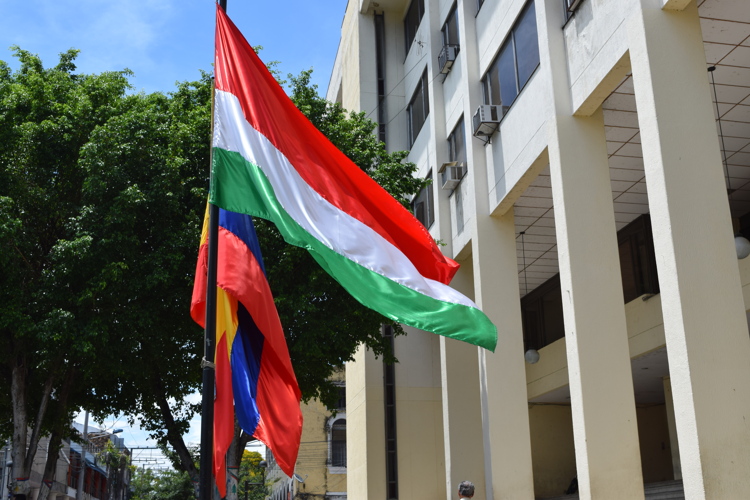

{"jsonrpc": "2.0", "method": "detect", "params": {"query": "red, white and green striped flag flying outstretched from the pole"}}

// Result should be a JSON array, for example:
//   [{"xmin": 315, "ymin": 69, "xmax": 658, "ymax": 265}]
[{"xmin": 209, "ymin": 6, "xmax": 497, "ymax": 351}]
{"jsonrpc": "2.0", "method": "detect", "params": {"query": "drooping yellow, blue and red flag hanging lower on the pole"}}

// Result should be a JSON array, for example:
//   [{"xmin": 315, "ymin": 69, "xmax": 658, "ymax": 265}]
[{"xmin": 190, "ymin": 209, "xmax": 302, "ymax": 497}]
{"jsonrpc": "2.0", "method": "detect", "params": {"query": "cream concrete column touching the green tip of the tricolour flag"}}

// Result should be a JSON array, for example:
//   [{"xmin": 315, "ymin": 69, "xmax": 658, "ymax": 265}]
[{"xmin": 472, "ymin": 208, "xmax": 534, "ymax": 500}]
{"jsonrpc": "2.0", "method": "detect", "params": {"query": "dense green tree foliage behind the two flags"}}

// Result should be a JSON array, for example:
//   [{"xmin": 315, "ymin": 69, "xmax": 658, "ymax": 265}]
[{"xmin": 0, "ymin": 48, "xmax": 423, "ymax": 477}]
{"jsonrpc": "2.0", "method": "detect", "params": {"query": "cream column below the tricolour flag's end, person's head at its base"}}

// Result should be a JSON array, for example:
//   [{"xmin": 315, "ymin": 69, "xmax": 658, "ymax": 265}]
[{"xmin": 440, "ymin": 261, "xmax": 485, "ymax": 500}]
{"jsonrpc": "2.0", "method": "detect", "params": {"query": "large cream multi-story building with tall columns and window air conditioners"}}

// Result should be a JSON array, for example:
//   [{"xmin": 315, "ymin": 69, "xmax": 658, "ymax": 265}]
[{"xmin": 328, "ymin": 0, "xmax": 750, "ymax": 500}]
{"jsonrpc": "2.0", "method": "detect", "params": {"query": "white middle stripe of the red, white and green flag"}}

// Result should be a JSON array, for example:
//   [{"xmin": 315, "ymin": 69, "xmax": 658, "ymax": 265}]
[{"xmin": 213, "ymin": 90, "xmax": 477, "ymax": 308}]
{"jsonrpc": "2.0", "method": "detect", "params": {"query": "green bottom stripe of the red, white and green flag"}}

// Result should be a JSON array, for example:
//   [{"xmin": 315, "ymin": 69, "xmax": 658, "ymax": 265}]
[{"xmin": 210, "ymin": 148, "xmax": 497, "ymax": 351}]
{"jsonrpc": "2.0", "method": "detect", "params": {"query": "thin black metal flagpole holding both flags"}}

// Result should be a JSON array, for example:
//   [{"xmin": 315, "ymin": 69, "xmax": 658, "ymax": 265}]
[{"xmin": 198, "ymin": 0, "xmax": 227, "ymax": 500}]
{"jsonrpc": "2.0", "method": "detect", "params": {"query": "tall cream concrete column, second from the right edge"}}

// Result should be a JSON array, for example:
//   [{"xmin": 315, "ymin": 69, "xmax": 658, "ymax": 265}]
[{"xmin": 537, "ymin": 1, "xmax": 644, "ymax": 500}]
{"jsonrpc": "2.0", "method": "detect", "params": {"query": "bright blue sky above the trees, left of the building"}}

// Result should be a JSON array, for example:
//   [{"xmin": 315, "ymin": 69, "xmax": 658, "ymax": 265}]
[{"xmin": 0, "ymin": 0, "xmax": 346, "ymax": 95}]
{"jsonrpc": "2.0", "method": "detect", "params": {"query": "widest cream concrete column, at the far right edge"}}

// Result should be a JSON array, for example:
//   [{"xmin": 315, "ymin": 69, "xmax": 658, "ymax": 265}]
[{"xmin": 628, "ymin": 0, "xmax": 750, "ymax": 499}]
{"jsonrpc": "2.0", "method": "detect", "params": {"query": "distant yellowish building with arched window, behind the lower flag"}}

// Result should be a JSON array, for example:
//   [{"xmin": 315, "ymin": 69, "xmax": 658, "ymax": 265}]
[{"xmin": 266, "ymin": 371, "xmax": 347, "ymax": 500}]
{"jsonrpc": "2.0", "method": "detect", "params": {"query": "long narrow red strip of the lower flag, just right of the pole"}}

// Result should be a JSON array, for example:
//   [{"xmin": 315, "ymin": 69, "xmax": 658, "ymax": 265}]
[{"xmin": 214, "ymin": 332, "xmax": 234, "ymax": 498}]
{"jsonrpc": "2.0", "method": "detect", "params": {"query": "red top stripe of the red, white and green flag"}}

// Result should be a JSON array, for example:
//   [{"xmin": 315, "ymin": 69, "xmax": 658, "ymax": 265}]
[{"xmin": 215, "ymin": 4, "xmax": 458, "ymax": 283}]
